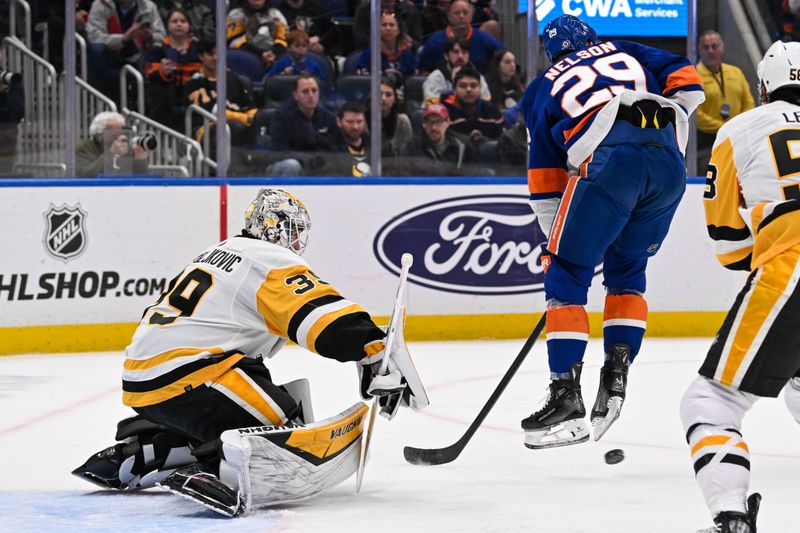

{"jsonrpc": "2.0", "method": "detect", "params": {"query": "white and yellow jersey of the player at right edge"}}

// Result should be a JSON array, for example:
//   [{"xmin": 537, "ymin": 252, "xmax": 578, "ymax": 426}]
[{"xmin": 703, "ymin": 101, "xmax": 800, "ymax": 270}]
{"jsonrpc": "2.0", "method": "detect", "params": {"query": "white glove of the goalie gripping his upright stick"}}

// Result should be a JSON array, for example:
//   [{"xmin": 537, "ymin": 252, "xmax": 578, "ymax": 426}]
[{"xmin": 358, "ymin": 350, "xmax": 410, "ymax": 420}]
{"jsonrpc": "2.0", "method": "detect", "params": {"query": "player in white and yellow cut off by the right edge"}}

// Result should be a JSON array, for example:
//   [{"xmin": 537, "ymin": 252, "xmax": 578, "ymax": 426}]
[{"xmin": 681, "ymin": 42, "xmax": 800, "ymax": 533}]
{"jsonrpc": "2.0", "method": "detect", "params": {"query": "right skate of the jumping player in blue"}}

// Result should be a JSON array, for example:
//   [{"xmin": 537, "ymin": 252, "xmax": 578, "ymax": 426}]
[{"xmin": 591, "ymin": 344, "xmax": 631, "ymax": 441}]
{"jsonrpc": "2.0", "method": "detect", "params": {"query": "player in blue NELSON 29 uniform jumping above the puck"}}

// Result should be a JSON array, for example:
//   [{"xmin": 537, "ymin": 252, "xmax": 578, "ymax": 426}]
[{"xmin": 521, "ymin": 15, "xmax": 705, "ymax": 449}]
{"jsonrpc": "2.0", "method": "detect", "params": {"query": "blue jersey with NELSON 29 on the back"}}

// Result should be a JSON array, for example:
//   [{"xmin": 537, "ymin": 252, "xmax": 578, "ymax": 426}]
[{"xmin": 520, "ymin": 41, "xmax": 705, "ymax": 200}]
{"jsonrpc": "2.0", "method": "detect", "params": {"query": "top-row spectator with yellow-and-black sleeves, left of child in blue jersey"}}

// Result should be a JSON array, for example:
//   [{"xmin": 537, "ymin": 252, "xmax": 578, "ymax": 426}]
[{"xmin": 227, "ymin": 0, "xmax": 287, "ymax": 70}]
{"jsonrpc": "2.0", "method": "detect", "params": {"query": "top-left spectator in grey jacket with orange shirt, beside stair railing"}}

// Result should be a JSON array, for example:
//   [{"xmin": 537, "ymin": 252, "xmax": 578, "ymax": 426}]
[{"xmin": 87, "ymin": 0, "xmax": 166, "ymax": 100}]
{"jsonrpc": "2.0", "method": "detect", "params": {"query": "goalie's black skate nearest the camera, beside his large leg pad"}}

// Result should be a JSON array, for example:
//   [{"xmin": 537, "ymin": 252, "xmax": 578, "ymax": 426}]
[{"xmin": 157, "ymin": 463, "xmax": 244, "ymax": 518}]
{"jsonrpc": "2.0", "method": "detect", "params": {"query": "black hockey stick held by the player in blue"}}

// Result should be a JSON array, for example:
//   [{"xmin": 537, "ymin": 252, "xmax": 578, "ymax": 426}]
[{"xmin": 403, "ymin": 314, "xmax": 545, "ymax": 465}]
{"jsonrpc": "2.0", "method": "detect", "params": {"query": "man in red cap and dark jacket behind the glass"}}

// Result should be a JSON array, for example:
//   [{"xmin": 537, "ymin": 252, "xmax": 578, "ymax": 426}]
[{"xmin": 392, "ymin": 104, "xmax": 478, "ymax": 176}]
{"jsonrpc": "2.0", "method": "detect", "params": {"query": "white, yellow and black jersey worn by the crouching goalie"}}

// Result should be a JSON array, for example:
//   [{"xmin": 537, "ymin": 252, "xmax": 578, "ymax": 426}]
[{"xmin": 122, "ymin": 236, "xmax": 384, "ymax": 407}]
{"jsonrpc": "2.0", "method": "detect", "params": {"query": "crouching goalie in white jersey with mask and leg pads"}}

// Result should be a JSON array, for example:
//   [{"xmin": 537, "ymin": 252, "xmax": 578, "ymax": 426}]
[{"xmin": 73, "ymin": 189, "xmax": 427, "ymax": 516}]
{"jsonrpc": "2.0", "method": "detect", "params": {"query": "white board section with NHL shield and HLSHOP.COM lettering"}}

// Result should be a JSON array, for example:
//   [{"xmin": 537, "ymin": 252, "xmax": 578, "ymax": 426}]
[{"xmin": 0, "ymin": 187, "xmax": 219, "ymax": 327}]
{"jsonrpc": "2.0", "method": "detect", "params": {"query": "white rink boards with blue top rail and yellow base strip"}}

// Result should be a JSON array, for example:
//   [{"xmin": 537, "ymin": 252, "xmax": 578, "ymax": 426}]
[{"xmin": 0, "ymin": 178, "xmax": 743, "ymax": 353}]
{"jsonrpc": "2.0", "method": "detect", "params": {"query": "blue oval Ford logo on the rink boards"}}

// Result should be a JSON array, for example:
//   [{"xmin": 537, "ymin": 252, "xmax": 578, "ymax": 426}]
[{"xmin": 373, "ymin": 194, "xmax": 545, "ymax": 295}]
